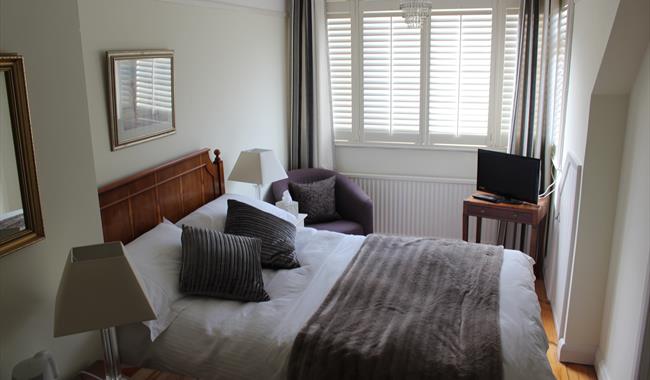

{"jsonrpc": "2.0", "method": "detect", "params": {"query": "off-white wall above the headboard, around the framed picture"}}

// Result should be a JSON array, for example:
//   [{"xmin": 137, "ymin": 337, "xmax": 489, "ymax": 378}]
[{"xmin": 79, "ymin": 0, "xmax": 289, "ymax": 195}]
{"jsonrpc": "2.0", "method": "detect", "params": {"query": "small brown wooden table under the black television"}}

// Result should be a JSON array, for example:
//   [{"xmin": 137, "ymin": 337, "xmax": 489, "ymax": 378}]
[{"xmin": 463, "ymin": 192, "xmax": 548, "ymax": 267}]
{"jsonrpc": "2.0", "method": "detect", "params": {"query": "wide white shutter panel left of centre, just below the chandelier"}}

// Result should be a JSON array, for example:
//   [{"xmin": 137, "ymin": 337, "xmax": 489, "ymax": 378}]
[{"xmin": 363, "ymin": 15, "xmax": 420, "ymax": 142}]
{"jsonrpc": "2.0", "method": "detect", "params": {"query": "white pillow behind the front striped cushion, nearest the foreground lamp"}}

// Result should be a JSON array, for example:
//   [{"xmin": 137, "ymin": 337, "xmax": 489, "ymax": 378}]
[{"xmin": 125, "ymin": 220, "xmax": 183, "ymax": 341}]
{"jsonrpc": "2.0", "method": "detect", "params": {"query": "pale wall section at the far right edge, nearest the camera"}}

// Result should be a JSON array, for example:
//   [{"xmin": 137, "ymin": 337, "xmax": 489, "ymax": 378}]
[{"xmin": 597, "ymin": 45, "xmax": 650, "ymax": 380}]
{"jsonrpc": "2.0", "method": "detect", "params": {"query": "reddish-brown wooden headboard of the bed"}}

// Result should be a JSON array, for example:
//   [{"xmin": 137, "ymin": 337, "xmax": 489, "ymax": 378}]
[{"xmin": 97, "ymin": 149, "xmax": 226, "ymax": 244}]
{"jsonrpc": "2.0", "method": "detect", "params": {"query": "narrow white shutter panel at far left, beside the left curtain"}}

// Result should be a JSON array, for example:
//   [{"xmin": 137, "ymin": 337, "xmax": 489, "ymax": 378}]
[{"xmin": 327, "ymin": 17, "xmax": 352, "ymax": 141}]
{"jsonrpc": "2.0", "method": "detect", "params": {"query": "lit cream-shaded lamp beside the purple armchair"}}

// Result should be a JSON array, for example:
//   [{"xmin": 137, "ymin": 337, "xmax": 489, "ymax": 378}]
[{"xmin": 228, "ymin": 149, "xmax": 287, "ymax": 200}]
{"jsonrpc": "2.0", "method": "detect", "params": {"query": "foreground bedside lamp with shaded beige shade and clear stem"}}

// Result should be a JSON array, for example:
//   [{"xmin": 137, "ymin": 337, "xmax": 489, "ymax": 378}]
[{"xmin": 54, "ymin": 242, "xmax": 156, "ymax": 380}]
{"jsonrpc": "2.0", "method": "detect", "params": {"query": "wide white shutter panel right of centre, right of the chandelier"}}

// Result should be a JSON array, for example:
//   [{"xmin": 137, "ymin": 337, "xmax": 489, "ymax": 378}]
[{"xmin": 429, "ymin": 9, "xmax": 492, "ymax": 141}]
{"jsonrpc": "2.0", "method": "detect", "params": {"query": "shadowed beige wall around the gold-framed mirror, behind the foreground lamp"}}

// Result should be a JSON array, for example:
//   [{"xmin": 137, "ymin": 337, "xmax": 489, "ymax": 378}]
[{"xmin": 0, "ymin": 0, "xmax": 102, "ymax": 379}]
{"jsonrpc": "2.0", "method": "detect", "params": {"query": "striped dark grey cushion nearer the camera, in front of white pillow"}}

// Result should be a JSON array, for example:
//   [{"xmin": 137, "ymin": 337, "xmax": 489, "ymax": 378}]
[{"xmin": 179, "ymin": 226, "xmax": 270, "ymax": 302}]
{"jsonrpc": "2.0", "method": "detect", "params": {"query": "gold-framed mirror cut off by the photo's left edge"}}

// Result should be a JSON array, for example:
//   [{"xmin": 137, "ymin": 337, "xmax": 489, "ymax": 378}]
[{"xmin": 0, "ymin": 54, "xmax": 45, "ymax": 257}]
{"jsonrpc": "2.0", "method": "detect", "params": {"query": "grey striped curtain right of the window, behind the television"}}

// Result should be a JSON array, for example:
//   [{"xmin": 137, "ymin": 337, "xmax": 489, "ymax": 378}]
[{"xmin": 498, "ymin": 0, "xmax": 558, "ymax": 247}]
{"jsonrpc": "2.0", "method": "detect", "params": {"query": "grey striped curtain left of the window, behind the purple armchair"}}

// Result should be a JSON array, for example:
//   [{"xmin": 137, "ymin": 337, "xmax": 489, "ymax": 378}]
[{"xmin": 289, "ymin": 0, "xmax": 334, "ymax": 169}]
